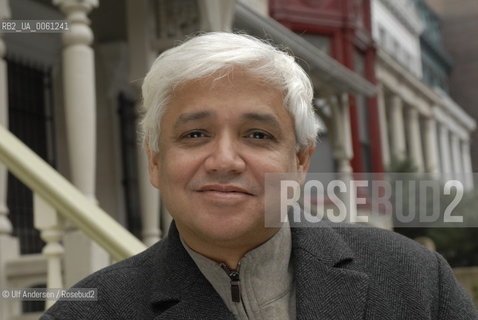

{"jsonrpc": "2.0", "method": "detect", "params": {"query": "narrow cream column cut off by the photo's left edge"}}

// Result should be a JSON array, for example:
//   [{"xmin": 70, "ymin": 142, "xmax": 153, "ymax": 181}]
[{"xmin": 0, "ymin": 0, "xmax": 12, "ymax": 237}]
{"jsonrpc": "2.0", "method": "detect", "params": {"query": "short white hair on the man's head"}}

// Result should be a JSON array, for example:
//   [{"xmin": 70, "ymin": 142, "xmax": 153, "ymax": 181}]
[{"xmin": 141, "ymin": 32, "xmax": 319, "ymax": 152}]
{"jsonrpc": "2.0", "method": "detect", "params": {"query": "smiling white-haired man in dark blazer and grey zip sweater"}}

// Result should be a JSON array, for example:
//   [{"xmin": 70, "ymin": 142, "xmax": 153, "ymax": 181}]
[{"xmin": 42, "ymin": 33, "xmax": 477, "ymax": 320}]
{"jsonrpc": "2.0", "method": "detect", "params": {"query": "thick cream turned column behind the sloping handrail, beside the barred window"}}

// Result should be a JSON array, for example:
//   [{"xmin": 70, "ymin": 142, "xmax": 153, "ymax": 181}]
[{"xmin": 53, "ymin": 0, "xmax": 109, "ymax": 287}]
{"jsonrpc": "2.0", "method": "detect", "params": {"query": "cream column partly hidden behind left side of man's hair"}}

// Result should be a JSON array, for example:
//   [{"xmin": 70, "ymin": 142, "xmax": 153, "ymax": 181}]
[{"xmin": 126, "ymin": 0, "xmax": 161, "ymax": 246}]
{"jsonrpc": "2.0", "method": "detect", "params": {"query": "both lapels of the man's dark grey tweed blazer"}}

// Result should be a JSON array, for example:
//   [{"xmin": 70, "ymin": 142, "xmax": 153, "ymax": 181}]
[{"xmin": 150, "ymin": 222, "xmax": 368, "ymax": 320}]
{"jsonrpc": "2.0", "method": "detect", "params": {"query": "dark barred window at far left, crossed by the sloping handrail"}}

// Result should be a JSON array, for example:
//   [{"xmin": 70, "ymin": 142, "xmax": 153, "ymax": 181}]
[{"xmin": 6, "ymin": 56, "xmax": 56, "ymax": 254}]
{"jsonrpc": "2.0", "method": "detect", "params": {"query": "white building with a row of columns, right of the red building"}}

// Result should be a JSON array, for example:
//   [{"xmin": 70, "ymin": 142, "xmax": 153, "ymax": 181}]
[{"xmin": 372, "ymin": 0, "xmax": 476, "ymax": 185}]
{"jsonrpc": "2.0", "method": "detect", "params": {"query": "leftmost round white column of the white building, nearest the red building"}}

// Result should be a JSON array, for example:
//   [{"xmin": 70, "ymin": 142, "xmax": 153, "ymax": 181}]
[{"xmin": 390, "ymin": 94, "xmax": 407, "ymax": 161}]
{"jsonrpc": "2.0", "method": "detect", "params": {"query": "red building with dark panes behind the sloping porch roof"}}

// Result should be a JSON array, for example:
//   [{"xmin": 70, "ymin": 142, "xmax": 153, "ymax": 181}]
[{"xmin": 269, "ymin": 0, "xmax": 384, "ymax": 172}]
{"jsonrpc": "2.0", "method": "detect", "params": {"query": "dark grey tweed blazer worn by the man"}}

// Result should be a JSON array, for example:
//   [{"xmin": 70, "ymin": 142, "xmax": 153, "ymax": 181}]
[{"xmin": 40, "ymin": 223, "xmax": 478, "ymax": 320}]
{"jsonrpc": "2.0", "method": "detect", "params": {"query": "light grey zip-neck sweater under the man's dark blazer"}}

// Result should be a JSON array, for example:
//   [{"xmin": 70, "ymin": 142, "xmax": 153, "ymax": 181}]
[{"xmin": 181, "ymin": 225, "xmax": 295, "ymax": 320}]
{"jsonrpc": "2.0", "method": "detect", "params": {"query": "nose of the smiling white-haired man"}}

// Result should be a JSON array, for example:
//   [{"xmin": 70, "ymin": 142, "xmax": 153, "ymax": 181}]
[{"xmin": 204, "ymin": 134, "xmax": 246, "ymax": 174}]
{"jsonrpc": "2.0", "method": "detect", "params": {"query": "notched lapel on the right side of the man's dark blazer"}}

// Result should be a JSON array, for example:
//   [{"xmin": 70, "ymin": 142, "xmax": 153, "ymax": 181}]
[{"xmin": 292, "ymin": 226, "xmax": 368, "ymax": 320}]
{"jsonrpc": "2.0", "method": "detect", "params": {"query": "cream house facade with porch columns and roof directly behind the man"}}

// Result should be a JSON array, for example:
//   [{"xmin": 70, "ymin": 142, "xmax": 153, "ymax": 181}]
[{"xmin": 0, "ymin": 0, "xmax": 375, "ymax": 319}]
